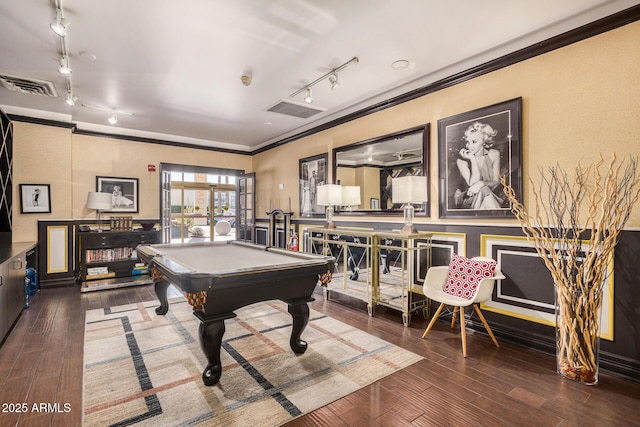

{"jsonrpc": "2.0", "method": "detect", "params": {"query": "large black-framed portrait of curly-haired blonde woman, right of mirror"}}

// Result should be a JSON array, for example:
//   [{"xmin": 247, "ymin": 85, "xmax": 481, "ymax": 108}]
[{"xmin": 438, "ymin": 98, "xmax": 522, "ymax": 218}]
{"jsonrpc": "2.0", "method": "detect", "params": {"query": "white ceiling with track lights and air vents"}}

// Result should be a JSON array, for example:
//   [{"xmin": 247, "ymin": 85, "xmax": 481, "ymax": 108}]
[{"xmin": 0, "ymin": 0, "xmax": 638, "ymax": 151}]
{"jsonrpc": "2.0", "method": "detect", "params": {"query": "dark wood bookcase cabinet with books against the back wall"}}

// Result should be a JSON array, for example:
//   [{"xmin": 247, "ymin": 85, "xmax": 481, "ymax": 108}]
[{"xmin": 77, "ymin": 230, "xmax": 161, "ymax": 292}]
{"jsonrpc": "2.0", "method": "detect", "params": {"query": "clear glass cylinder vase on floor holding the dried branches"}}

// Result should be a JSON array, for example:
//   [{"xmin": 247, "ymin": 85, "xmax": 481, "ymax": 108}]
[{"xmin": 555, "ymin": 285, "xmax": 602, "ymax": 385}]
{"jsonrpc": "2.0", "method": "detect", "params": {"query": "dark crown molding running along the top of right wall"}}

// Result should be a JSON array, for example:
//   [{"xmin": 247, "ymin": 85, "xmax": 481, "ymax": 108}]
[{"xmin": 252, "ymin": 5, "xmax": 640, "ymax": 154}]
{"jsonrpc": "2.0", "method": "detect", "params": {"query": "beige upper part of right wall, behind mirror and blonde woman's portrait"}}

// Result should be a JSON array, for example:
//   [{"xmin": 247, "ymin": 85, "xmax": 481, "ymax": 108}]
[{"xmin": 254, "ymin": 22, "xmax": 640, "ymax": 226}]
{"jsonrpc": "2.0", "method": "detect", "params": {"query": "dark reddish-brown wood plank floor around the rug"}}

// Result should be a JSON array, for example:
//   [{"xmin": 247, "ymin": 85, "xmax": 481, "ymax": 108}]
[{"xmin": 0, "ymin": 286, "xmax": 640, "ymax": 427}]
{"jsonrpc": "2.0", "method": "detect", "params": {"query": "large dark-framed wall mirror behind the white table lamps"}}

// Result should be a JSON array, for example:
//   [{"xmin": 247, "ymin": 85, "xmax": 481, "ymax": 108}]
[{"xmin": 333, "ymin": 123, "xmax": 430, "ymax": 215}]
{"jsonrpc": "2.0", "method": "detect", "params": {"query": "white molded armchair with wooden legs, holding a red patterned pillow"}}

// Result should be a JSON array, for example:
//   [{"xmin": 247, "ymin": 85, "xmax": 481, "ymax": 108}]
[{"xmin": 422, "ymin": 257, "xmax": 505, "ymax": 357}]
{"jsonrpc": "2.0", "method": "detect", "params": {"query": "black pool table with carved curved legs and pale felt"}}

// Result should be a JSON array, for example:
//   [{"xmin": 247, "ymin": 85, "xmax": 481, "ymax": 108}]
[{"xmin": 136, "ymin": 241, "xmax": 335, "ymax": 386}]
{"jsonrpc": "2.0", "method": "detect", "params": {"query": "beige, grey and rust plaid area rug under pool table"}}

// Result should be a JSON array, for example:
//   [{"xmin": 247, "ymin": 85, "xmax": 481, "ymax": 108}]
[{"xmin": 83, "ymin": 299, "xmax": 422, "ymax": 427}]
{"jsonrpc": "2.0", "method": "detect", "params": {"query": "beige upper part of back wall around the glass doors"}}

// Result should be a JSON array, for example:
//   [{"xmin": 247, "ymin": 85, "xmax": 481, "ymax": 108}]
[{"xmin": 12, "ymin": 122, "xmax": 252, "ymax": 242}]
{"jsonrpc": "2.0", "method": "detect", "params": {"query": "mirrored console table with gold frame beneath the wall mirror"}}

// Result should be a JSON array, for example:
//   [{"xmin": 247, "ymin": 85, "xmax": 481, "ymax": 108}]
[{"xmin": 308, "ymin": 228, "xmax": 432, "ymax": 326}]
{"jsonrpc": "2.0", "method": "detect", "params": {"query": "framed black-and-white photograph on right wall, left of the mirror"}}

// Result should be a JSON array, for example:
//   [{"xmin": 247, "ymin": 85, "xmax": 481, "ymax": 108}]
[{"xmin": 300, "ymin": 153, "xmax": 329, "ymax": 217}]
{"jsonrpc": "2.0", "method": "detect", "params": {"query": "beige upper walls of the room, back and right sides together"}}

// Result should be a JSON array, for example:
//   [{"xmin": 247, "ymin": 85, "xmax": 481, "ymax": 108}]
[{"xmin": 8, "ymin": 22, "xmax": 640, "ymax": 241}]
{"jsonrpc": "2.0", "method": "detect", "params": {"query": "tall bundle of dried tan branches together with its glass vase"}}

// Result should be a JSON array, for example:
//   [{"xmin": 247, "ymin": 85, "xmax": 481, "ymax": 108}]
[{"xmin": 501, "ymin": 154, "xmax": 640, "ymax": 382}]
